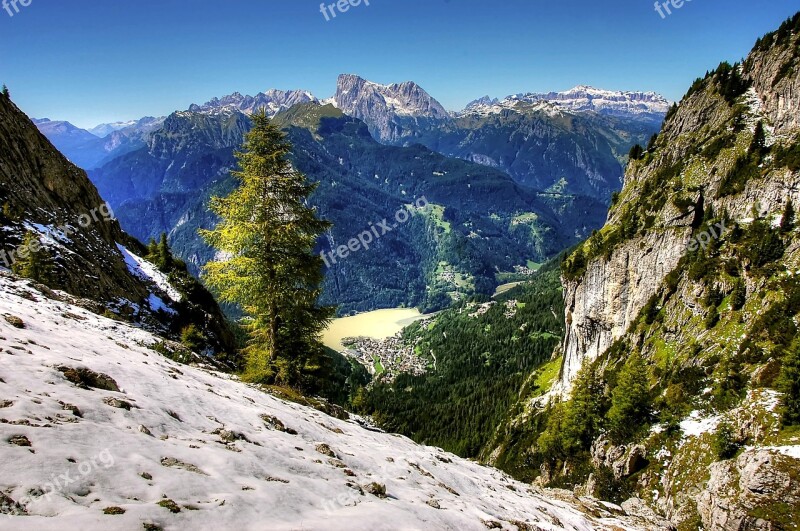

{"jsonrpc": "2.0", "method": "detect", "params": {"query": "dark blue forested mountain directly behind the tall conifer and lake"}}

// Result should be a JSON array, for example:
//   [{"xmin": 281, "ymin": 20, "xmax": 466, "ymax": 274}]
[{"xmin": 91, "ymin": 103, "xmax": 604, "ymax": 313}]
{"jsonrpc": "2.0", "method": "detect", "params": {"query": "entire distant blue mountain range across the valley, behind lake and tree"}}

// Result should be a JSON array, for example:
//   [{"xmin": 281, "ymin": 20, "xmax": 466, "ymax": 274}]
[{"xmin": 32, "ymin": 75, "xmax": 665, "ymax": 314}]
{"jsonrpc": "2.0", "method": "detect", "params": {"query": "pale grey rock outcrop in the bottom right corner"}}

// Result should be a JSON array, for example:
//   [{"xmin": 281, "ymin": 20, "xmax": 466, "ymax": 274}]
[{"xmin": 697, "ymin": 450, "xmax": 800, "ymax": 531}]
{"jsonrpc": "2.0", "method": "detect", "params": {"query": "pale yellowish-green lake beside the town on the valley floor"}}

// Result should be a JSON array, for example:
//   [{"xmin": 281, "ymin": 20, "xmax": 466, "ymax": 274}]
[{"xmin": 322, "ymin": 308, "xmax": 427, "ymax": 352}]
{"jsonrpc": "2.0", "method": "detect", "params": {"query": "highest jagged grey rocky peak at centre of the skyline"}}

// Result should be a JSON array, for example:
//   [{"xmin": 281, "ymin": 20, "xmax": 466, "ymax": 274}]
[{"xmin": 333, "ymin": 74, "xmax": 451, "ymax": 143}]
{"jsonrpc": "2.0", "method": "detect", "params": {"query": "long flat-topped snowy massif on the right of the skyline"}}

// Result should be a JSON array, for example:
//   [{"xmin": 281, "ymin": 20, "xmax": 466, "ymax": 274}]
[{"xmin": 461, "ymin": 85, "xmax": 671, "ymax": 123}]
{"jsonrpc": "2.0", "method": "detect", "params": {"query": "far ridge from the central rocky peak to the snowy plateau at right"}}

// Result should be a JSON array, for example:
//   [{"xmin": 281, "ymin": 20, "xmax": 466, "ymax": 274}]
[{"xmin": 334, "ymin": 75, "xmax": 669, "ymax": 203}]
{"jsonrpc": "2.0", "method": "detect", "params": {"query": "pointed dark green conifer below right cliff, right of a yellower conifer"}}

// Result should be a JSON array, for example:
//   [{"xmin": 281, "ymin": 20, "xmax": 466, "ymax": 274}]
[{"xmin": 608, "ymin": 352, "xmax": 650, "ymax": 442}]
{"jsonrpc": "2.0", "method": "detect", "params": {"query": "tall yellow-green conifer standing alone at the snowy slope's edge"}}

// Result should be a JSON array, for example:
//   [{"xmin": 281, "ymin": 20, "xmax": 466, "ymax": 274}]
[{"xmin": 201, "ymin": 112, "xmax": 333, "ymax": 383}]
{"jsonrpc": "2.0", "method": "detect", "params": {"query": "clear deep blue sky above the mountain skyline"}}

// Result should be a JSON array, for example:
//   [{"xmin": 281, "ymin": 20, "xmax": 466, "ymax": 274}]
[{"xmin": 0, "ymin": 0, "xmax": 800, "ymax": 127}]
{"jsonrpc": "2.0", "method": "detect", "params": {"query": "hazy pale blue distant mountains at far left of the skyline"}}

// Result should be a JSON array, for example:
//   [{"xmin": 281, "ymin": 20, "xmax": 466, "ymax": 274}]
[{"xmin": 34, "ymin": 117, "xmax": 164, "ymax": 170}]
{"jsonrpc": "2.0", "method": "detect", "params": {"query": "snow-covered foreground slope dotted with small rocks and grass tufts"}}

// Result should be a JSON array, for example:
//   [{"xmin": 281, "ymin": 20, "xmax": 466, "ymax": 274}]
[{"xmin": 0, "ymin": 274, "xmax": 660, "ymax": 530}]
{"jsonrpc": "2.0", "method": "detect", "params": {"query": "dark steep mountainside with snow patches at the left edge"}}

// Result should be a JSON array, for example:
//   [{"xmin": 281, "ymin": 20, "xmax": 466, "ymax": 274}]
[{"xmin": 0, "ymin": 97, "xmax": 233, "ymax": 357}]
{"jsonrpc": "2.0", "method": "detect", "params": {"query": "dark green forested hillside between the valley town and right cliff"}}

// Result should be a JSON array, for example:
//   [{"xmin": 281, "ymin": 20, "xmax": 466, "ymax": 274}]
[{"xmin": 356, "ymin": 261, "xmax": 564, "ymax": 457}]
